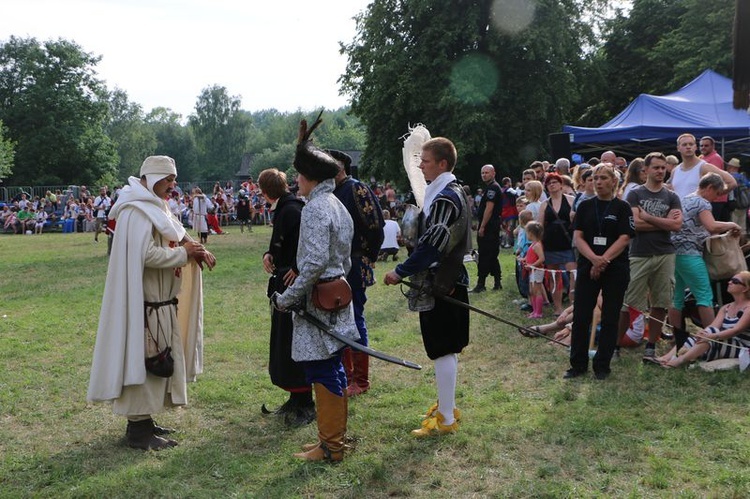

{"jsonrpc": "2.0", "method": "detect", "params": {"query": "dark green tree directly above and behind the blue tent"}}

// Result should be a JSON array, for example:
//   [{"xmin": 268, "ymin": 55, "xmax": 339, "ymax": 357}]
[{"xmin": 570, "ymin": 0, "xmax": 733, "ymax": 127}]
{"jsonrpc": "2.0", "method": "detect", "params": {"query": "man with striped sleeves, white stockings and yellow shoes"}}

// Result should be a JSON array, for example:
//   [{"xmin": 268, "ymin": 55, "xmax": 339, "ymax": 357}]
[{"xmin": 385, "ymin": 138, "xmax": 471, "ymax": 436}]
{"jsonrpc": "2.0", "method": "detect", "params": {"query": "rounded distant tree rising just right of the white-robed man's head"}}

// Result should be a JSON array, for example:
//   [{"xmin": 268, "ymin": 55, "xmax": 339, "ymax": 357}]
[{"xmin": 189, "ymin": 85, "xmax": 251, "ymax": 180}]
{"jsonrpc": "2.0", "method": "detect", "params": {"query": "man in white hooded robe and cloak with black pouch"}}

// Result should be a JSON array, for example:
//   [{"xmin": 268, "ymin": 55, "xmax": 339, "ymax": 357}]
[{"xmin": 87, "ymin": 156, "xmax": 216, "ymax": 450}]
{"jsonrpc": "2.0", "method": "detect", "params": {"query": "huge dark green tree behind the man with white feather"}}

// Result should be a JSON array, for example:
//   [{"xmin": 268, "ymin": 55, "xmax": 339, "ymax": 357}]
[{"xmin": 341, "ymin": 0, "xmax": 600, "ymax": 185}]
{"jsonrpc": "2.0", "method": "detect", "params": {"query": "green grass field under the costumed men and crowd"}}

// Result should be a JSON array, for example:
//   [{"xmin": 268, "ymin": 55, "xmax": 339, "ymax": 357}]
[{"xmin": 0, "ymin": 227, "xmax": 750, "ymax": 498}]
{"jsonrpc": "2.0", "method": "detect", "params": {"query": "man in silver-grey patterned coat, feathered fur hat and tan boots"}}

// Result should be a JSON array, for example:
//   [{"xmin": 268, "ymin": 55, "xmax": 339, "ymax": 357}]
[{"xmin": 271, "ymin": 117, "xmax": 359, "ymax": 461}]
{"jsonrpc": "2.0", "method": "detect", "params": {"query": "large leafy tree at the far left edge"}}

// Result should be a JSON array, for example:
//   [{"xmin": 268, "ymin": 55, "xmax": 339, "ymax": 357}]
[{"xmin": 0, "ymin": 37, "xmax": 117, "ymax": 185}]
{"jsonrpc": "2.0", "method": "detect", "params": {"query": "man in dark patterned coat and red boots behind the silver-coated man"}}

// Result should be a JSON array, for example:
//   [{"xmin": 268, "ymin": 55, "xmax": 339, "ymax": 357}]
[{"xmin": 328, "ymin": 150, "xmax": 385, "ymax": 397}]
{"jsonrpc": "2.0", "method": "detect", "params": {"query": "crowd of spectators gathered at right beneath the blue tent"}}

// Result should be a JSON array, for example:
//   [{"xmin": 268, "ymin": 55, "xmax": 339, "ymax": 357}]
[{"xmin": 494, "ymin": 134, "xmax": 750, "ymax": 379}]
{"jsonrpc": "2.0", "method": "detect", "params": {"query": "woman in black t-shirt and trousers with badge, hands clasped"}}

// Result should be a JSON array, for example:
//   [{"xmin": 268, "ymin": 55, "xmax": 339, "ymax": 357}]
[{"xmin": 563, "ymin": 163, "xmax": 635, "ymax": 380}]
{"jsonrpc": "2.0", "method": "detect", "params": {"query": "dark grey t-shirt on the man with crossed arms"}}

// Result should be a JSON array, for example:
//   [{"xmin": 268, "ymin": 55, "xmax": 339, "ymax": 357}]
[{"xmin": 626, "ymin": 185, "xmax": 682, "ymax": 256}]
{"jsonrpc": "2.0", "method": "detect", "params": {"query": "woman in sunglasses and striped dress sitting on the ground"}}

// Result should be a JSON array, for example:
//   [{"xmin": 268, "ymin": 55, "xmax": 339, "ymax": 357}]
[{"xmin": 659, "ymin": 271, "xmax": 750, "ymax": 368}]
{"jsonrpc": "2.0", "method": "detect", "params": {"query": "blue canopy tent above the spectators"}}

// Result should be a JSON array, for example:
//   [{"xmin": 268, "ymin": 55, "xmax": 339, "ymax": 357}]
[{"xmin": 563, "ymin": 69, "xmax": 750, "ymax": 158}]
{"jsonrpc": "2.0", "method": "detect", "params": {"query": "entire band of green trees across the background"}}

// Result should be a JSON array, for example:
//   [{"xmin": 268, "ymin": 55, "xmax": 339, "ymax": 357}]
[{"xmin": 0, "ymin": 0, "xmax": 734, "ymax": 188}]
